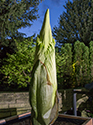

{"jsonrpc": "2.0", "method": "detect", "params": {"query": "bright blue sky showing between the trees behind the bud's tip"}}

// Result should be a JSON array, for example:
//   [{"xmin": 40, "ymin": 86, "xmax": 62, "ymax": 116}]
[{"xmin": 18, "ymin": 0, "xmax": 72, "ymax": 37}]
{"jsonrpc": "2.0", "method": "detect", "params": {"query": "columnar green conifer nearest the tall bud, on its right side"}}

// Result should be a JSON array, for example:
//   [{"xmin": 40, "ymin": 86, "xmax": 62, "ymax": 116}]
[{"xmin": 56, "ymin": 43, "xmax": 72, "ymax": 88}]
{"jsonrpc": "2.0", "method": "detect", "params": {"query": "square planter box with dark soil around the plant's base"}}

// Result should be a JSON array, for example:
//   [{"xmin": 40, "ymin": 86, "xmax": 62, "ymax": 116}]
[{"xmin": 0, "ymin": 112, "xmax": 93, "ymax": 125}]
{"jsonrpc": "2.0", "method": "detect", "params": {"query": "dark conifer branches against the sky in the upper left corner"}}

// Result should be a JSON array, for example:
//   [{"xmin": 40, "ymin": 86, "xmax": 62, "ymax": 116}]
[{"xmin": 0, "ymin": 0, "xmax": 42, "ymax": 39}]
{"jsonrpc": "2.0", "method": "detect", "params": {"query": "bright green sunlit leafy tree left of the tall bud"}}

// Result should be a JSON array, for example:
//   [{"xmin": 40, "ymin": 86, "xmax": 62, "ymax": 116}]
[{"xmin": 0, "ymin": 39, "xmax": 35, "ymax": 87}]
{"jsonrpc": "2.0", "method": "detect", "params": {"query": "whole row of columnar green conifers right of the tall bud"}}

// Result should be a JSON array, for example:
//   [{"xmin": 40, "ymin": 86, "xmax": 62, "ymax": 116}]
[{"xmin": 56, "ymin": 41, "xmax": 93, "ymax": 89}]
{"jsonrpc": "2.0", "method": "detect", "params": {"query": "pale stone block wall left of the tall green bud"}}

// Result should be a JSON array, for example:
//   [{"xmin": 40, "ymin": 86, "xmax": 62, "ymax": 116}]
[{"xmin": 0, "ymin": 92, "xmax": 31, "ymax": 118}]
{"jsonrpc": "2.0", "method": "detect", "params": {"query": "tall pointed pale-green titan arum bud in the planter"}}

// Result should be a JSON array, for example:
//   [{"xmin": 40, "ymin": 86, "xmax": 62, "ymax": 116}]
[{"xmin": 29, "ymin": 9, "xmax": 58, "ymax": 125}]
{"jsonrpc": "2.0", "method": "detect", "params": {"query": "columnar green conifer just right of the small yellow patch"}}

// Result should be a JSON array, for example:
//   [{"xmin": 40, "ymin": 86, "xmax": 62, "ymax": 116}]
[{"xmin": 73, "ymin": 41, "xmax": 90, "ymax": 87}]
